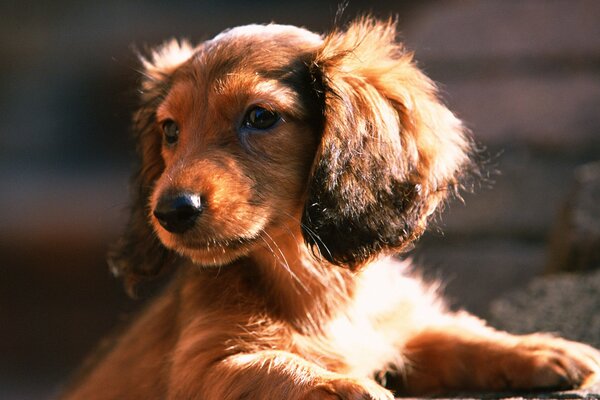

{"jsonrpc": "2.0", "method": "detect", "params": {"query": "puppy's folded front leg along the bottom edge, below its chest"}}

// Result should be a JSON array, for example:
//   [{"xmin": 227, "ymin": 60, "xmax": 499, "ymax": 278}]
[{"xmin": 169, "ymin": 350, "xmax": 393, "ymax": 400}]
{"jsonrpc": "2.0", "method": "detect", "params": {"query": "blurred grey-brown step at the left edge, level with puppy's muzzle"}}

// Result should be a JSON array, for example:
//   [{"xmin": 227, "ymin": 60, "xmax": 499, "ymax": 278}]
[{"xmin": 0, "ymin": 165, "xmax": 129, "ymax": 242}]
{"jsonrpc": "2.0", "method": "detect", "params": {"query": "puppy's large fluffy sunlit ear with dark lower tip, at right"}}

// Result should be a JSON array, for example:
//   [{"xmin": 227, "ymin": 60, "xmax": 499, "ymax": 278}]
[{"xmin": 302, "ymin": 18, "xmax": 470, "ymax": 268}]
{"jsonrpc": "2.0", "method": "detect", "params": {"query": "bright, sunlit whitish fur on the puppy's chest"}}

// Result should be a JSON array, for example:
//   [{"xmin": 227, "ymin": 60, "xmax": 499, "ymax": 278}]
[{"xmin": 308, "ymin": 260, "xmax": 436, "ymax": 376}]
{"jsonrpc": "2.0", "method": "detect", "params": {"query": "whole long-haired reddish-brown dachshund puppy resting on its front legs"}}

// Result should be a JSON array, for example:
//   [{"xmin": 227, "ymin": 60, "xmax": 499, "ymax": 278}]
[{"xmin": 65, "ymin": 18, "xmax": 600, "ymax": 400}]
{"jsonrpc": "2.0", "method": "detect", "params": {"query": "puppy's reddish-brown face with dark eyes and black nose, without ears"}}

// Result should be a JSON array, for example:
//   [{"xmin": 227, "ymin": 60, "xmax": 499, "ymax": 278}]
[{"xmin": 148, "ymin": 26, "xmax": 320, "ymax": 265}]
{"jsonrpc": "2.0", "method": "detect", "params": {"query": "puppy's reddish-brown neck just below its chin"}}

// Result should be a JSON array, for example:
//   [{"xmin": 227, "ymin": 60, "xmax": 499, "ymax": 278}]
[{"xmin": 179, "ymin": 225, "xmax": 356, "ymax": 334}]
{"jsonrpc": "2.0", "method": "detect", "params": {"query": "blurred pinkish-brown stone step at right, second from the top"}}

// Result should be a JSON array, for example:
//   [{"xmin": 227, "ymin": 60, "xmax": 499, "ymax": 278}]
[{"xmin": 442, "ymin": 75, "xmax": 600, "ymax": 151}]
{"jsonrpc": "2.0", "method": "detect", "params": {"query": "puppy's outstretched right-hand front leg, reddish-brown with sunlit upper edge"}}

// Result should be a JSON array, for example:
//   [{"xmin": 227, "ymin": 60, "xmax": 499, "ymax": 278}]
[{"xmin": 404, "ymin": 313, "xmax": 600, "ymax": 395}]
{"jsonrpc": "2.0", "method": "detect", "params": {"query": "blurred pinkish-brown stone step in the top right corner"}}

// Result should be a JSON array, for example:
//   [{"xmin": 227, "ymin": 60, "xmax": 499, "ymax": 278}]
[{"xmin": 403, "ymin": 0, "xmax": 600, "ymax": 60}]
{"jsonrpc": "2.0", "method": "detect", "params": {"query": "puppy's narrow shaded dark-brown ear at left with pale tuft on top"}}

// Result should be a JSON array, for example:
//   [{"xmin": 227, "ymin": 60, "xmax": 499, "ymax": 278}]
[{"xmin": 108, "ymin": 40, "xmax": 193, "ymax": 292}]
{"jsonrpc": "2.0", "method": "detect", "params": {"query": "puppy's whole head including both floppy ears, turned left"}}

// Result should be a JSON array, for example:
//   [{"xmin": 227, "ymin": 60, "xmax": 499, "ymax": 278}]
[{"xmin": 111, "ymin": 19, "xmax": 469, "ymax": 288}]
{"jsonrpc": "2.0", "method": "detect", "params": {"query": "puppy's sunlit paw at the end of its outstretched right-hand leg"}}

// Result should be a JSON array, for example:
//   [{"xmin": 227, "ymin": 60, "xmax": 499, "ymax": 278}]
[{"xmin": 501, "ymin": 335, "xmax": 600, "ymax": 390}]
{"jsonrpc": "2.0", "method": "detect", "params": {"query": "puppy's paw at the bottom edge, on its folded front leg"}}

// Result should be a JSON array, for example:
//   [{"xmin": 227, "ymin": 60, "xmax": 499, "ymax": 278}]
[{"xmin": 303, "ymin": 378, "xmax": 394, "ymax": 400}]
